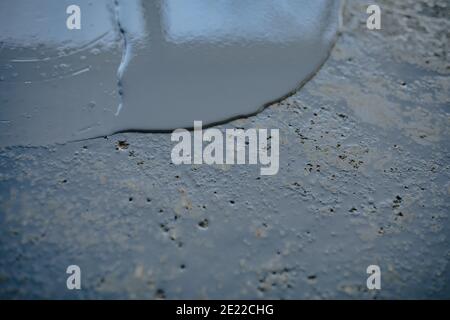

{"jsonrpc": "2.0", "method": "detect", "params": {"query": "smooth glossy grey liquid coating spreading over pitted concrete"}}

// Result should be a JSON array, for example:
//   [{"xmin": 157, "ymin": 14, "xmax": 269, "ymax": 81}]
[{"xmin": 0, "ymin": 0, "xmax": 341, "ymax": 146}]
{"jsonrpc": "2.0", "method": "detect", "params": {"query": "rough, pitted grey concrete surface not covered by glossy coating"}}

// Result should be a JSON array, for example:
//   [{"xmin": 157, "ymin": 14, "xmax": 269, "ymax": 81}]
[{"xmin": 0, "ymin": 0, "xmax": 450, "ymax": 299}]
